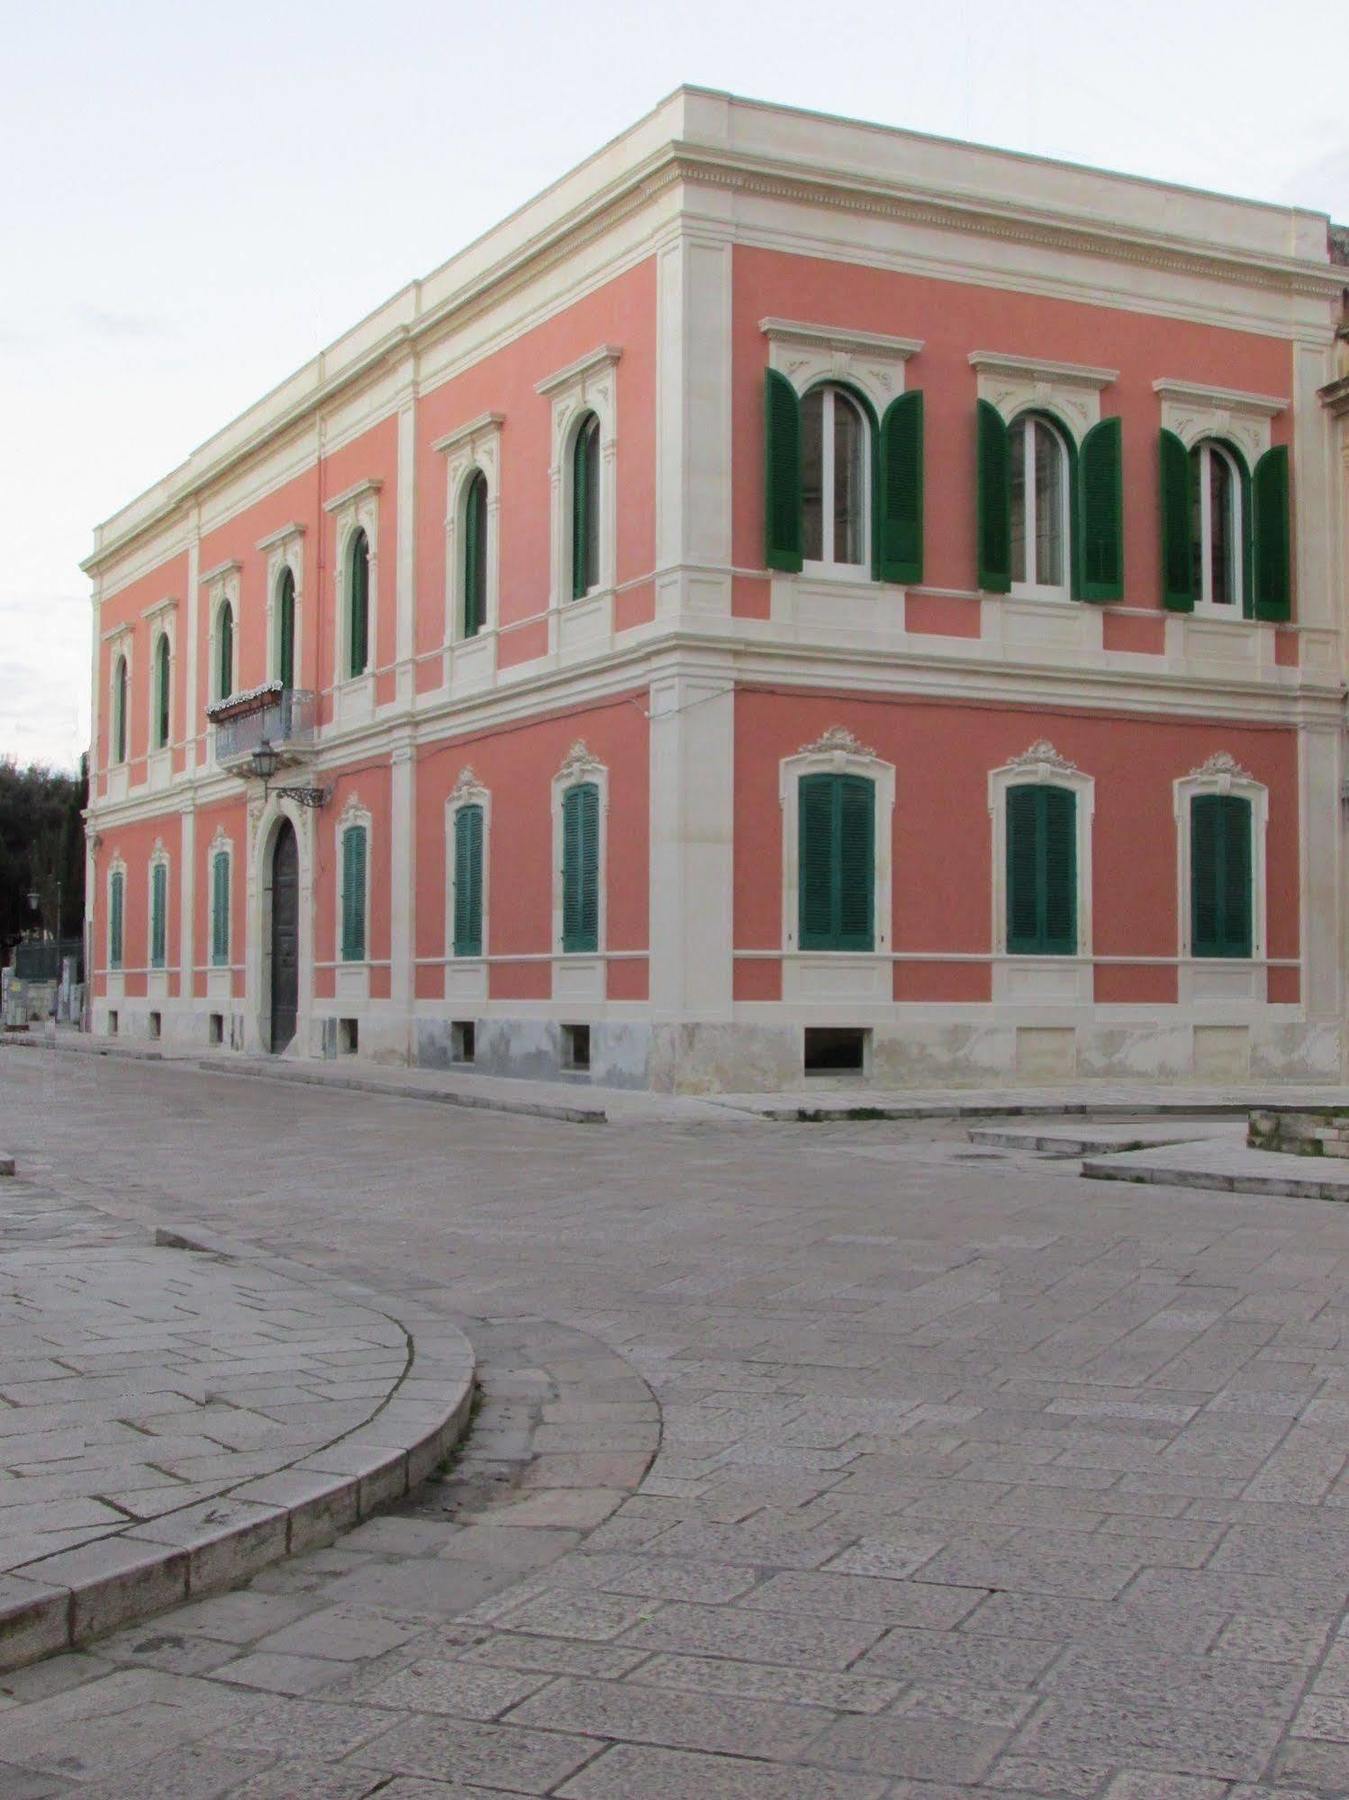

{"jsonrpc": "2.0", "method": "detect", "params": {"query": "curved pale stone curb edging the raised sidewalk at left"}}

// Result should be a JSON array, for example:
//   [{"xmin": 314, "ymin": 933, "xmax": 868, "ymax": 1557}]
[{"xmin": 0, "ymin": 1231, "xmax": 475, "ymax": 1670}]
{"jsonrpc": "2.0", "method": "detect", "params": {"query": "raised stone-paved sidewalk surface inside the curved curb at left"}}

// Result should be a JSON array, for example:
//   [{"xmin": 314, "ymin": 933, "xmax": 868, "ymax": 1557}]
[{"xmin": 0, "ymin": 1181, "xmax": 411, "ymax": 1579}]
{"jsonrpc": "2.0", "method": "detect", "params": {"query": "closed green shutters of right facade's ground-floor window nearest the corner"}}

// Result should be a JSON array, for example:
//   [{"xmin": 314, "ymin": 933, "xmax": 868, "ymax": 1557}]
[{"xmin": 798, "ymin": 776, "xmax": 875, "ymax": 950}]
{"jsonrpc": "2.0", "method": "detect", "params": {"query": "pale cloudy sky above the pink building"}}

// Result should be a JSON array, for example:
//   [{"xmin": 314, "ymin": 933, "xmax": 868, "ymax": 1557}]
[{"xmin": 0, "ymin": 0, "xmax": 1349, "ymax": 769}]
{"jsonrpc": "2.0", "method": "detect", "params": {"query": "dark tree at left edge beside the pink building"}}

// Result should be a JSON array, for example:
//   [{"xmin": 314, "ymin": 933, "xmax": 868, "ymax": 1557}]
[{"xmin": 0, "ymin": 756, "xmax": 88, "ymax": 961}]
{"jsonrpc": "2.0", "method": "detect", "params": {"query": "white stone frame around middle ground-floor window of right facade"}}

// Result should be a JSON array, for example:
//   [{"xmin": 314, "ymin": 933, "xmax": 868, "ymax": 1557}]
[{"xmin": 989, "ymin": 738, "xmax": 1097, "ymax": 1003}]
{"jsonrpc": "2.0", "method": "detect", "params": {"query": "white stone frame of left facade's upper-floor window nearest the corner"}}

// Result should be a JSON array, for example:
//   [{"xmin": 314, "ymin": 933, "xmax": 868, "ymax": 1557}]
[{"xmin": 535, "ymin": 344, "xmax": 623, "ymax": 614}]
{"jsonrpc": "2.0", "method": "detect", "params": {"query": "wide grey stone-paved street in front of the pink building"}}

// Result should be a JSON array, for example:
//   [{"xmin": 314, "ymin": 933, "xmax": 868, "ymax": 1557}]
[{"xmin": 0, "ymin": 1053, "xmax": 1349, "ymax": 1800}]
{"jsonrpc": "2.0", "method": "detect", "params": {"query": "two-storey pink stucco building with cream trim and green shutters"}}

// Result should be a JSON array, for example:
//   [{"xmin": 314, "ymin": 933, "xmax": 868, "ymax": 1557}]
[{"xmin": 86, "ymin": 90, "xmax": 1349, "ymax": 1089}]
